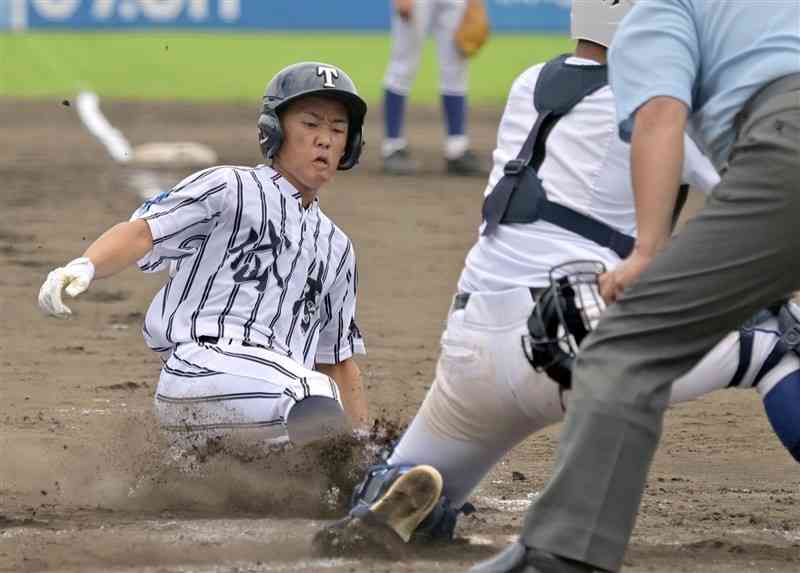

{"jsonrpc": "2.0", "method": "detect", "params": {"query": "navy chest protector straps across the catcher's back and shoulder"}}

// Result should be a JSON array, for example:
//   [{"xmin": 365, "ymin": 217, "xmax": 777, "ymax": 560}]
[{"xmin": 483, "ymin": 55, "xmax": 633, "ymax": 258}]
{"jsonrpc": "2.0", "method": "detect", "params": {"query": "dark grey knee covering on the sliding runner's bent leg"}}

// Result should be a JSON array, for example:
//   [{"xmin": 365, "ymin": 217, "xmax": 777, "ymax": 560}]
[{"xmin": 286, "ymin": 396, "xmax": 350, "ymax": 446}]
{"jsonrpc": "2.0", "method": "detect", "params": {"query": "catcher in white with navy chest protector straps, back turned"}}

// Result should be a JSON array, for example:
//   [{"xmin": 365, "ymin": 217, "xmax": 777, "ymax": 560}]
[{"xmin": 314, "ymin": 0, "xmax": 800, "ymax": 560}]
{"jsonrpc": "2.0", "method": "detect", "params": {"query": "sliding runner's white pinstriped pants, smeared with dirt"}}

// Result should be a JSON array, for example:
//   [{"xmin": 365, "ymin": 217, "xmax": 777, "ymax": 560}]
[{"xmin": 155, "ymin": 339, "xmax": 341, "ymax": 448}]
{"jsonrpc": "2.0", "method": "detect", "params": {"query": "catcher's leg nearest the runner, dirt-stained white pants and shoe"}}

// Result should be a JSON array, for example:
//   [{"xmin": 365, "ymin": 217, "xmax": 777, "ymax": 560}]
[{"xmin": 314, "ymin": 289, "xmax": 562, "ymax": 555}]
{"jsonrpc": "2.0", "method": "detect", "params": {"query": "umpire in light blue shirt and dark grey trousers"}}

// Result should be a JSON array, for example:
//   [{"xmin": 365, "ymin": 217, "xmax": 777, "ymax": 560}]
[{"xmin": 472, "ymin": 0, "xmax": 800, "ymax": 573}]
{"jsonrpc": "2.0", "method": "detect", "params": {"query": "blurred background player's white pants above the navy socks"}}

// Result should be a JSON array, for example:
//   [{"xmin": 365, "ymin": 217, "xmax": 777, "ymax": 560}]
[{"xmin": 384, "ymin": 0, "xmax": 467, "ymax": 95}]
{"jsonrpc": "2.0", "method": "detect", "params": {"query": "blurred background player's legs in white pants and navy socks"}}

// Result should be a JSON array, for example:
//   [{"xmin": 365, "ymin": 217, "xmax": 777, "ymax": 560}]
[{"xmin": 381, "ymin": 0, "xmax": 486, "ymax": 176}]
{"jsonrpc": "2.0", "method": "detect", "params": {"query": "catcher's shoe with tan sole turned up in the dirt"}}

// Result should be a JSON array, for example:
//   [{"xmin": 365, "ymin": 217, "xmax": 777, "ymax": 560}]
[{"xmin": 312, "ymin": 466, "xmax": 443, "ymax": 557}]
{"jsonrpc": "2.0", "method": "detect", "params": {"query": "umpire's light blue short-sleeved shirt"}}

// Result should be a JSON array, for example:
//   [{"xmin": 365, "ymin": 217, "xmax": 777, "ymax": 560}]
[{"xmin": 609, "ymin": 0, "xmax": 800, "ymax": 168}]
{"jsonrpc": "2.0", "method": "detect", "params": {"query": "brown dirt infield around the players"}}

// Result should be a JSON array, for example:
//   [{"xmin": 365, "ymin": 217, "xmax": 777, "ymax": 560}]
[{"xmin": 0, "ymin": 99, "xmax": 800, "ymax": 573}]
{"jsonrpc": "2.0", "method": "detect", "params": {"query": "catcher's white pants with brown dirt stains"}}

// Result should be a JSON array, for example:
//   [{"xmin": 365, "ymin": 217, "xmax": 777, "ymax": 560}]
[{"xmin": 388, "ymin": 288, "xmax": 800, "ymax": 507}]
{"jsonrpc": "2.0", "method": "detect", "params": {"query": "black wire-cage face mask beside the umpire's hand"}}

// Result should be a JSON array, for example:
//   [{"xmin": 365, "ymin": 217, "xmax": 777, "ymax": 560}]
[{"xmin": 522, "ymin": 261, "xmax": 606, "ymax": 388}]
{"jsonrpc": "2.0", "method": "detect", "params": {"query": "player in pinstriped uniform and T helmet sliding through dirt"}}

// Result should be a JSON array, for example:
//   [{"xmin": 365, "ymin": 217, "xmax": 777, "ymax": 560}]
[{"xmin": 39, "ymin": 62, "xmax": 367, "ymax": 454}]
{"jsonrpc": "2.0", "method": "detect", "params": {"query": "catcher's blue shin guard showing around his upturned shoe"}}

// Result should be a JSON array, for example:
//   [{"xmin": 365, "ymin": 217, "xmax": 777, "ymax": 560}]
[{"xmin": 350, "ymin": 464, "xmax": 475, "ymax": 543}]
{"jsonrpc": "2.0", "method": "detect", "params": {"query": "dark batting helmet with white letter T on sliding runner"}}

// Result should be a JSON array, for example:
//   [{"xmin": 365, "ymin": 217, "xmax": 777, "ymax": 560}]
[{"xmin": 258, "ymin": 62, "xmax": 367, "ymax": 170}]
